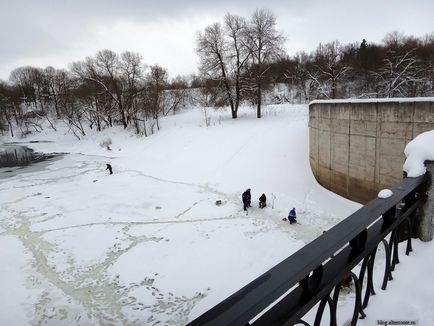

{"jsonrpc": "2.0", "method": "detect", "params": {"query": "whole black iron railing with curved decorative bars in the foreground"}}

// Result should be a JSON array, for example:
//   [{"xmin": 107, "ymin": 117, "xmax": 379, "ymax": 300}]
[{"xmin": 188, "ymin": 176, "xmax": 426, "ymax": 326}]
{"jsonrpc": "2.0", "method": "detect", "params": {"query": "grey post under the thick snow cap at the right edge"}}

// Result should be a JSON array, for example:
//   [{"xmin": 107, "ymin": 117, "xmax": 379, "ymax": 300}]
[{"xmin": 417, "ymin": 161, "xmax": 434, "ymax": 241}]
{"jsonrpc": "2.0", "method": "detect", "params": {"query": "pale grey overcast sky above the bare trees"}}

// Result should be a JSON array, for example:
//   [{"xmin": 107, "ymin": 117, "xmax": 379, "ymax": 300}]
[{"xmin": 0, "ymin": 0, "xmax": 434, "ymax": 79}]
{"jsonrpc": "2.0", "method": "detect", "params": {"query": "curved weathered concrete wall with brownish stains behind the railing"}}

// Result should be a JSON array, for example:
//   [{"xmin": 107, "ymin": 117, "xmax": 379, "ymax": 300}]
[{"xmin": 309, "ymin": 98, "xmax": 434, "ymax": 204}]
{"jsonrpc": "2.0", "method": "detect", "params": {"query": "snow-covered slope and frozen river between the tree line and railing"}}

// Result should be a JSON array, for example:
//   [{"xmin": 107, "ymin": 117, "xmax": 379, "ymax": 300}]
[{"xmin": 0, "ymin": 105, "xmax": 434, "ymax": 325}]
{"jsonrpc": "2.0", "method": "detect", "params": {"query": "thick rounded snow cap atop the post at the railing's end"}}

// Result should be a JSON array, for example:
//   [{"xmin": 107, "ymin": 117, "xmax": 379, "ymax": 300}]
[{"xmin": 403, "ymin": 130, "xmax": 434, "ymax": 177}]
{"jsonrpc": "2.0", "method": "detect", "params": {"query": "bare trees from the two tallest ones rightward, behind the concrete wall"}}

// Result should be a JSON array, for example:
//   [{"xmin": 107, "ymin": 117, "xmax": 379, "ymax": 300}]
[{"xmin": 194, "ymin": 9, "xmax": 434, "ymax": 114}]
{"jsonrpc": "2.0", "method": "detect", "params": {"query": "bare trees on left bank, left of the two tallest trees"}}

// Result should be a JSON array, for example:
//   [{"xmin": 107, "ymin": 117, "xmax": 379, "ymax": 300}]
[{"xmin": 0, "ymin": 50, "xmax": 187, "ymax": 138}]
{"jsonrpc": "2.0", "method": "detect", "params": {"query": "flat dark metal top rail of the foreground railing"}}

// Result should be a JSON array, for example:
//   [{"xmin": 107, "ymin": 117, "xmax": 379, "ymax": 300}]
[{"xmin": 189, "ymin": 176, "xmax": 425, "ymax": 326}]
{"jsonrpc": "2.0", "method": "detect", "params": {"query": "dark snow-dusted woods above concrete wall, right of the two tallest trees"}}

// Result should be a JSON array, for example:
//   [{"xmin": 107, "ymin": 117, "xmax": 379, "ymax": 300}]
[{"xmin": 267, "ymin": 32, "xmax": 434, "ymax": 102}]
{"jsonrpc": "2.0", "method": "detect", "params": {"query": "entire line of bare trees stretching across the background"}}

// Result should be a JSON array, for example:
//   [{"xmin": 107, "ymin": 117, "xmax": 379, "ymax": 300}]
[{"xmin": 0, "ymin": 9, "xmax": 434, "ymax": 138}]
